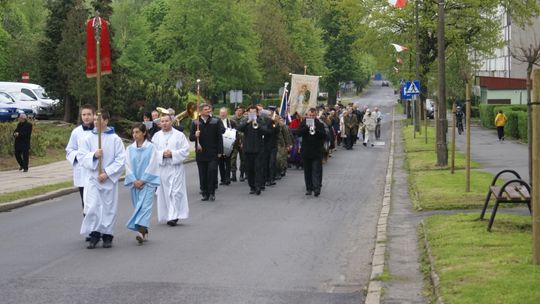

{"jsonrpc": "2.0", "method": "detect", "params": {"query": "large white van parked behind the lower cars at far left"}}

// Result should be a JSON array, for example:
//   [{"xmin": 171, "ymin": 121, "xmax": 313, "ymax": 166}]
[{"xmin": 0, "ymin": 81, "xmax": 58, "ymax": 118}]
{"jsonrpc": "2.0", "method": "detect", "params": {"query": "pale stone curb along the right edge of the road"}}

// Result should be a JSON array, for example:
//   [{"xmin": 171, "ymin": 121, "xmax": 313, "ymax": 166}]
[{"xmin": 364, "ymin": 108, "xmax": 395, "ymax": 304}]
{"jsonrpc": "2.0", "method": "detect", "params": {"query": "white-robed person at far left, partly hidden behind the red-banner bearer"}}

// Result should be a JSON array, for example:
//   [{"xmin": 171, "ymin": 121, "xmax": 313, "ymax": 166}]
[{"xmin": 66, "ymin": 104, "xmax": 95, "ymax": 216}]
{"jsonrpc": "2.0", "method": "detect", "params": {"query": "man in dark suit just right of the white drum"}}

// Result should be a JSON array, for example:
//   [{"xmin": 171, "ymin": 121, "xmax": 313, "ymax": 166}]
[{"xmin": 238, "ymin": 106, "xmax": 269, "ymax": 195}]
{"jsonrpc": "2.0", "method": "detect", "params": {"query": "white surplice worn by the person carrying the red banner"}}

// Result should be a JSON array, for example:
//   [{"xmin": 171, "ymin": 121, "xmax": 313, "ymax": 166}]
[{"xmin": 77, "ymin": 128, "xmax": 126, "ymax": 236}]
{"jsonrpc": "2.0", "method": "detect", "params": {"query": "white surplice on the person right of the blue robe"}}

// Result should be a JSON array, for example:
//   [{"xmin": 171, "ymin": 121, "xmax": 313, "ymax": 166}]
[{"xmin": 152, "ymin": 128, "xmax": 189, "ymax": 223}]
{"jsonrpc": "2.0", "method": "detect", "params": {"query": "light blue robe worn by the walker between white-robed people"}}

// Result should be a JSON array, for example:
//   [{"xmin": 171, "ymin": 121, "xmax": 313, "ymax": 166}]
[{"xmin": 124, "ymin": 141, "xmax": 160, "ymax": 231}]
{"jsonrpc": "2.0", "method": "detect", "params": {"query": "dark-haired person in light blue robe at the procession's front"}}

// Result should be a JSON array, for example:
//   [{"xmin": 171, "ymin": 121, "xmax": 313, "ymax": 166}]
[{"xmin": 124, "ymin": 124, "xmax": 160, "ymax": 245}]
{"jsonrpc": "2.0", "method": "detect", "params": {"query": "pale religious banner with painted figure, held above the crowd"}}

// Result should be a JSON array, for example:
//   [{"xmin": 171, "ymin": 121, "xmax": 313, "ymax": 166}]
[{"xmin": 289, "ymin": 74, "xmax": 319, "ymax": 116}]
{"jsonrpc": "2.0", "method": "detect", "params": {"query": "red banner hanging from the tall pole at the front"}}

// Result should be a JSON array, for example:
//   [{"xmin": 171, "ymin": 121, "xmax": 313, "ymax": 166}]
[{"xmin": 86, "ymin": 17, "xmax": 112, "ymax": 78}]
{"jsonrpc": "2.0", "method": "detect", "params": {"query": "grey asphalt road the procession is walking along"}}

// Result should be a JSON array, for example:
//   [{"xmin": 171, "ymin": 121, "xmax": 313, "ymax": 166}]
[{"xmin": 0, "ymin": 82, "xmax": 394, "ymax": 304}]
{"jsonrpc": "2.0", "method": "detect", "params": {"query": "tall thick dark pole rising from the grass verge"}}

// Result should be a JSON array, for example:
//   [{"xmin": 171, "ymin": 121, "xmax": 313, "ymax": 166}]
[{"xmin": 437, "ymin": 0, "xmax": 448, "ymax": 167}]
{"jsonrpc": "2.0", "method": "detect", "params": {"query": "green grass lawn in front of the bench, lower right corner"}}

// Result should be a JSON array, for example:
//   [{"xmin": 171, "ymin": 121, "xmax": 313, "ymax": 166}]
[{"xmin": 424, "ymin": 214, "xmax": 540, "ymax": 304}]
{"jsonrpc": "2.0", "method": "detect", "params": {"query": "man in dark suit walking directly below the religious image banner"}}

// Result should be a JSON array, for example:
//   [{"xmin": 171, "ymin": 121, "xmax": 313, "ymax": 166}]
[{"xmin": 298, "ymin": 108, "xmax": 326, "ymax": 196}]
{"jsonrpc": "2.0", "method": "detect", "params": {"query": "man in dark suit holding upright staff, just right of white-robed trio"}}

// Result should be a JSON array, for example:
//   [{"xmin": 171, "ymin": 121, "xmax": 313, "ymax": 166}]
[{"xmin": 189, "ymin": 104, "xmax": 224, "ymax": 201}]
